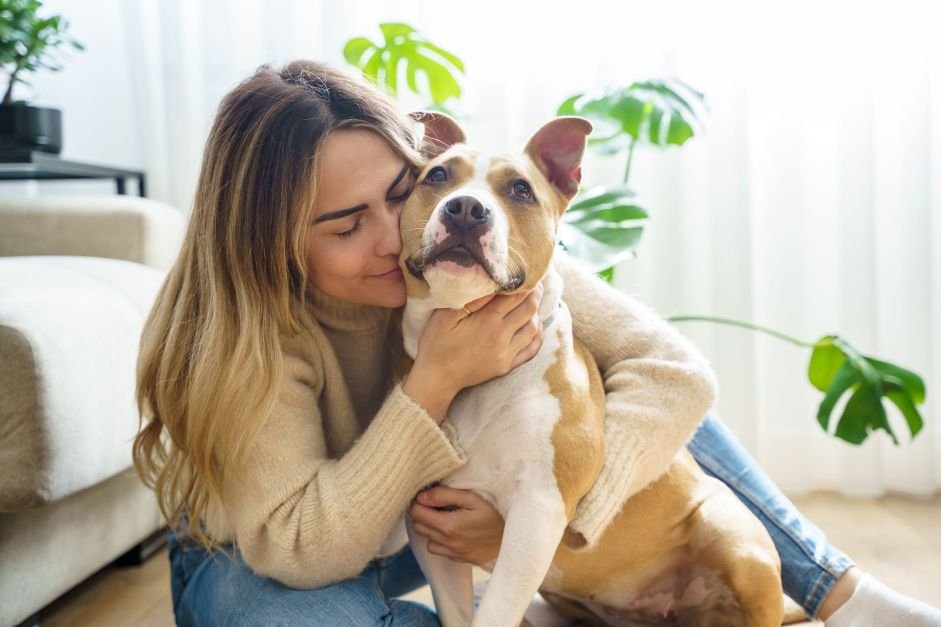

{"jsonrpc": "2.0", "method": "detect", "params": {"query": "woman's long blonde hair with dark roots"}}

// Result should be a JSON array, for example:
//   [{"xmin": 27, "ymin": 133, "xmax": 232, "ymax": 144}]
[{"xmin": 134, "ymin": 61, "xmax": 421, "ymax": 548}]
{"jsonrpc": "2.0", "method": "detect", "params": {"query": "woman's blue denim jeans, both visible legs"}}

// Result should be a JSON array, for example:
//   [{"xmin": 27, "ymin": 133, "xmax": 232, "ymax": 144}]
[{"xmin": 169, "ymin": 416, "xmax": 853, "ymax": 627}]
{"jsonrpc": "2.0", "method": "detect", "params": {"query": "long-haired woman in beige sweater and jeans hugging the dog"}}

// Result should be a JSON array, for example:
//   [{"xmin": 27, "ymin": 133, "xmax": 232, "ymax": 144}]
[{"xmin": 134, "ymin": 61, "xmax": 930, "ymax": 625}]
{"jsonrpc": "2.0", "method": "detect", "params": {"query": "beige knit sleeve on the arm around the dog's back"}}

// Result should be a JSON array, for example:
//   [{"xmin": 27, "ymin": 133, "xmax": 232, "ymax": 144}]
[{"xmin": 556, "ymin": 255, "xmax": 717, "ymax": 548}]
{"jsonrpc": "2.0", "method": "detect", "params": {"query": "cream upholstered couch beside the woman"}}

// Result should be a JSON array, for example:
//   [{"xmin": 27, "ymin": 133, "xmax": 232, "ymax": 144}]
[{"xmin": 0, "ymin": 196, "xmax": 183, "ymax": 627}]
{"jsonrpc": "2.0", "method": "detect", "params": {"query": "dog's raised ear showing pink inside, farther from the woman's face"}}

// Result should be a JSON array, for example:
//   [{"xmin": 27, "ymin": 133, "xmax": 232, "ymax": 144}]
[{"xmin": 525, "ymin": 116, "xmax": 592, "ymax": 198}]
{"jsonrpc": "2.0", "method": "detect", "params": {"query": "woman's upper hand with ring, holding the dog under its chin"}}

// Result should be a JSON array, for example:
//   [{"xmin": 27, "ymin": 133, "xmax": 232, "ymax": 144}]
[{"xmin": 402, "ymin": 285, "xmax": 543, "ymax": 423}]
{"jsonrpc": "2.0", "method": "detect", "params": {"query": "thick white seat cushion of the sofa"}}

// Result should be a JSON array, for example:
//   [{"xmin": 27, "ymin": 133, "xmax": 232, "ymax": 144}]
[{"xmin": 0, "ymin": 256, "xmax": 164, "ymax": 511}]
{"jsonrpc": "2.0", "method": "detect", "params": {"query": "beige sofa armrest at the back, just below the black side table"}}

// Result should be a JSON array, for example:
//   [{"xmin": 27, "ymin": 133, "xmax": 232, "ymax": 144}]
[{"xmin": 0, "ymin": 195, "xmax": 184, "ymax": 270}]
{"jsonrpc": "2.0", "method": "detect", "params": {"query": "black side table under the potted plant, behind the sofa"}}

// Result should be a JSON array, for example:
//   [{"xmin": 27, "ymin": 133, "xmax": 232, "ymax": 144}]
[{"xmin": 0, "ymin": 150, "xmax": 147, "ymax": 197}]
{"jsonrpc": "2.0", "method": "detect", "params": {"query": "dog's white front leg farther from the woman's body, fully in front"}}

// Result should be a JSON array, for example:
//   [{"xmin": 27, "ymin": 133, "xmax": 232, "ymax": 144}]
[{"xmin": 473, "ymin": 494, "xmax": 567, "ymax": 627}]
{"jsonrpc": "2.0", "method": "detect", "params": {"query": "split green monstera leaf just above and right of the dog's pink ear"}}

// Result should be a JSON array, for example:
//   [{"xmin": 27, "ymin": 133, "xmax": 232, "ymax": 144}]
[{"xmin": 558, "ymin": 79, "xmax": 705, "ymax": 154}]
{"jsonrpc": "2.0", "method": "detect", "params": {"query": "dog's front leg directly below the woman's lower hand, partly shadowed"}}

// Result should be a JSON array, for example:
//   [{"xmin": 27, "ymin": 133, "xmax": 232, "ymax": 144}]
[{"xmin": 405, "ymin": 516, "xmax": 474, "ymax": 627}]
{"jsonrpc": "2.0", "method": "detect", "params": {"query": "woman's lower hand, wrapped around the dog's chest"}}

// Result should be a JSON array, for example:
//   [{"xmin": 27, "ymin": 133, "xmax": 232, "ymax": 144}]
[{"xmin": 409, "ymin": 486, "xmax": 503, "ymax": 564}]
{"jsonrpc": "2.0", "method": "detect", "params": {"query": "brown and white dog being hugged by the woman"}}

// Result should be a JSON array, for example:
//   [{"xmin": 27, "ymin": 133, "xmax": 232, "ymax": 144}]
[{"xmin": 401, "ymin": 113, "xmax": 782, "ymax": 627}]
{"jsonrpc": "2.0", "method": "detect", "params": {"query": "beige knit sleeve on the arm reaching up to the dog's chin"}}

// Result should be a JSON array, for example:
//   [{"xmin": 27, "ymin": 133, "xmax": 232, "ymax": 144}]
[{"xmin": 223, "ymin": 334, "xmax": 465, "ymax": 588}]
